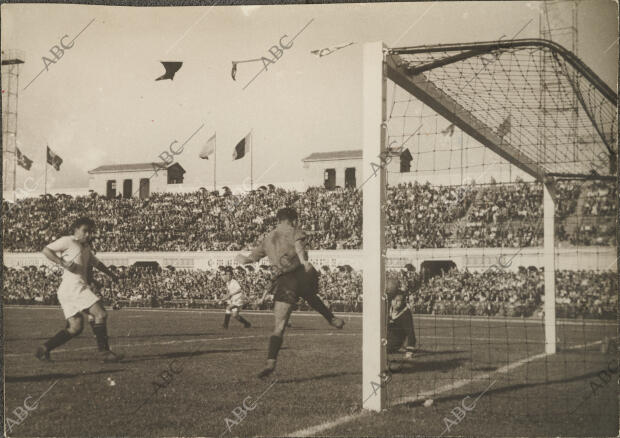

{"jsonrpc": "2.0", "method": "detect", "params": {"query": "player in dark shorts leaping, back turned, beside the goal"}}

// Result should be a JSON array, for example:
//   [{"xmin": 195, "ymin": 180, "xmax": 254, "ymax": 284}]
[{"xmin": 236, "ymin": 208, "xmax": 344, "ymax": 378}]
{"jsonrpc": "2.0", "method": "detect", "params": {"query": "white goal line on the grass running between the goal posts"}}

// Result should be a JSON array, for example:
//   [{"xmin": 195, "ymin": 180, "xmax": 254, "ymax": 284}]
[{"xmin": 284, "ymin": 340, "xmax": 616, "ymax": 437}]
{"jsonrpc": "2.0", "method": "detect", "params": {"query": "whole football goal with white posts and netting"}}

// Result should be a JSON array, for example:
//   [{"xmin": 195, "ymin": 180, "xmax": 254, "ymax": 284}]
[{"xmin": 362, "ymin": 39, "xmax": 618, "ymax": 435}]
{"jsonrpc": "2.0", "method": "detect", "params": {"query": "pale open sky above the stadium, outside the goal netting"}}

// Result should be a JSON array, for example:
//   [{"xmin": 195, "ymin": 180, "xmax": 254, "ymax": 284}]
[{"xmin": 1, "ymin": 0, "xmax": 618, "ymax": 187}]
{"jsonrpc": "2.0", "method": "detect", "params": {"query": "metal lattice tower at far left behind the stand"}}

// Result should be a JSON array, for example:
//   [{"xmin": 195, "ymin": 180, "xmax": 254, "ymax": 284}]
[{"xmin": 0, "ymin": 50, "xmax": 24, "ymax": 201}]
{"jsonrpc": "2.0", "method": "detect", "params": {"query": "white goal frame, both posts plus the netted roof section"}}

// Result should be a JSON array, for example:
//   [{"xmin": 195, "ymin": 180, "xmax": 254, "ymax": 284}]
[{"xmin": 362, "ymin": 40, "xmax": 617, "ymax": 411}]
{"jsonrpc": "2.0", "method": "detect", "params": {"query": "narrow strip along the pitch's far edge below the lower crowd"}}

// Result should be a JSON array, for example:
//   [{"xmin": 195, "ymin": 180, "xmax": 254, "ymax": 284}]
[{"xmin": 4, "ymin": 304, "xmax": 618, "ymax": 326}]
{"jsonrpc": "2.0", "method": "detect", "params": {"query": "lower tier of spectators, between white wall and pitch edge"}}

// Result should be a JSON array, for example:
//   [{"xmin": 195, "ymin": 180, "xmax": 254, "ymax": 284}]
[{"xmin": 3, "ymin": 265, "xmax": 618, "ymax": 318}]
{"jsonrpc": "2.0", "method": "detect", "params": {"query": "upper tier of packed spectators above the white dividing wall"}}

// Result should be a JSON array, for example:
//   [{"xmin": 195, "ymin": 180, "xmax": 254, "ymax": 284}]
[{"xmin": 2, "ymin": 182, "xmax": 617, "ymax": 252}]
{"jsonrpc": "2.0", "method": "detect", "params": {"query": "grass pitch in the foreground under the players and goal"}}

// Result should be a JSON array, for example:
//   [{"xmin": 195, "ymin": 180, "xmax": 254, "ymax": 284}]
[{"xmin": 4, "ymin": 306, "xmax": 618, "ymax": 437}]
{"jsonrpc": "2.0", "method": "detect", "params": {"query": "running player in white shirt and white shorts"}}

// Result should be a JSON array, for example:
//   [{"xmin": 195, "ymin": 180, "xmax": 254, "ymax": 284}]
[{"xmin": 35, "ymin": 217, "xmax": 122, "ymax": 362}]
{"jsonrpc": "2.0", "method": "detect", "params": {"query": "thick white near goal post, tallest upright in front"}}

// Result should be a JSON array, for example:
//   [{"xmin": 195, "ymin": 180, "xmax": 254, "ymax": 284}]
[{"xmin": 362, "ymin": 42, "xmax": 387, "ymax": 411}]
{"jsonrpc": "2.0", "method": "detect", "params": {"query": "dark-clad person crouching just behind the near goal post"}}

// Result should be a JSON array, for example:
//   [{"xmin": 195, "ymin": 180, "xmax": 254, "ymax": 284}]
[{"xmin": 386, "ymin": 279, "xmax": 416, "ymax": 359}]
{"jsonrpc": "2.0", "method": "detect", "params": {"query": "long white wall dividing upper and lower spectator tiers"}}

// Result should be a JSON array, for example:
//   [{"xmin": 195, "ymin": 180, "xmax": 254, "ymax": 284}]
[{"xmin": 4, "ymin": 246, "xmax": 617, "ymax": 271}]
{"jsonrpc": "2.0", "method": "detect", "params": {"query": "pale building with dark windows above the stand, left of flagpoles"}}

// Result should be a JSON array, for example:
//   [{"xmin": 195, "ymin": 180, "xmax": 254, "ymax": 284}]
[{"xmin": 88, "ymin": 162, "xmax": 185, "ymax": 199}]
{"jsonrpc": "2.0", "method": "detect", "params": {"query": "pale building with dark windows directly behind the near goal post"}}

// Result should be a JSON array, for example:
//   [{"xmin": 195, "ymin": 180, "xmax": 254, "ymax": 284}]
[{"xmin": 302, "ymin": 149, "xmax": 413, "ymax": 190}]
